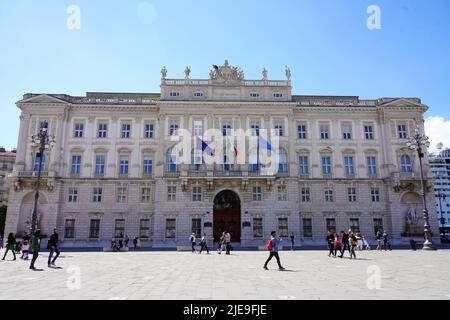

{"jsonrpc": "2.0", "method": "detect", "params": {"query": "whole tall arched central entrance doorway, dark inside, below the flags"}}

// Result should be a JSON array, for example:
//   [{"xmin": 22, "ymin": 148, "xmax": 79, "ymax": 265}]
[{"xmin": 213, "ymin": 190, "xmax": 241, "ymax": 242}]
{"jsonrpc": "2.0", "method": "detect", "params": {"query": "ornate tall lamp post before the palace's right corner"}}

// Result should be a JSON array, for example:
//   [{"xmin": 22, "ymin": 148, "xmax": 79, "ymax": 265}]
[{"xmin": 406, "ymin": 126, "xmax": 436, "ymax": 250}]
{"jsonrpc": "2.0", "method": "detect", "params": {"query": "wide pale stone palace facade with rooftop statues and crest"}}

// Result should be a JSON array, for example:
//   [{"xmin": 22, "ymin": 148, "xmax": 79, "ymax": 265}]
[{"xmin": 5, "ymin": 61, "xmax": 437, "ymax": 248}]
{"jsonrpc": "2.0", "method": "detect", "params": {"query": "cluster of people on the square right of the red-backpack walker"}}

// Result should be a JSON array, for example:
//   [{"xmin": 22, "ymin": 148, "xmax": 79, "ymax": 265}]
[{"xmin": 326, "ymin": 230, "xmax": 392, "ymax": 259}]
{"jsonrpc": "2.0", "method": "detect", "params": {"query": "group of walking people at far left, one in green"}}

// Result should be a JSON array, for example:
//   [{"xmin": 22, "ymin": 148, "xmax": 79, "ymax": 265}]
[{"xmin": 2, "ymin": 228, "xmax": 60, "ymax": 270}]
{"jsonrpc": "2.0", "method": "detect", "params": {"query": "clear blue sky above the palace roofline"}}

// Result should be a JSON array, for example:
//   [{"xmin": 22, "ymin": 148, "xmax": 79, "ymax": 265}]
[{"xmin": 0, "ymin": 0, "xmax": 450, "ymax": 149}]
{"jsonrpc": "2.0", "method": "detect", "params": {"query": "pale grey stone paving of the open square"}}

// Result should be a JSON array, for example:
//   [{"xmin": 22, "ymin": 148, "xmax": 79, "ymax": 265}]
[{"xmin": 0, "ymin": 250, "xmax": 450, "ymax": 300}]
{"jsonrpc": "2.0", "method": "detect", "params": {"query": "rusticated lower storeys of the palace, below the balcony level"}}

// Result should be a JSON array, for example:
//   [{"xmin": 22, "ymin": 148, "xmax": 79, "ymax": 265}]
[{"xmin": 5, "ymin": 177, "xmax": 437, "ymax": 248}]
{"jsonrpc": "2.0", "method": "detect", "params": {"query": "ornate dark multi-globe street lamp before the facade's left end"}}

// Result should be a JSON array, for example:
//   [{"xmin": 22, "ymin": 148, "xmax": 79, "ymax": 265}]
[{"xmin": 31, "ymin": 122, "xmax": 55, "ymax": 234}]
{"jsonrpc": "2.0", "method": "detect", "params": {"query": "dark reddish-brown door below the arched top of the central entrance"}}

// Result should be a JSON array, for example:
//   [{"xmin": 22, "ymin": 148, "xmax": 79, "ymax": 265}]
[{"xmin": 213, "ymin": 208, "xmax": 241, "ymax": 243}]
